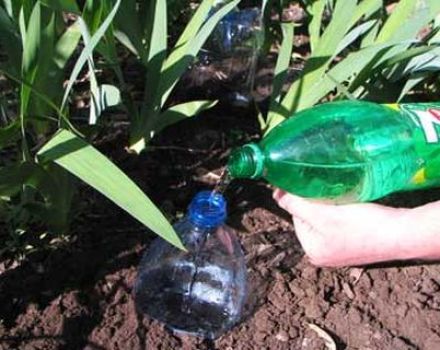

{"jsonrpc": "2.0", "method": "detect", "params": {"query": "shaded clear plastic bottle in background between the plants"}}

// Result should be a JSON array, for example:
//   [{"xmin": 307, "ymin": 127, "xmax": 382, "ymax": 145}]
[{"xmin": 185, "ymin": 0, "xmax": 263, "ymax": 107}]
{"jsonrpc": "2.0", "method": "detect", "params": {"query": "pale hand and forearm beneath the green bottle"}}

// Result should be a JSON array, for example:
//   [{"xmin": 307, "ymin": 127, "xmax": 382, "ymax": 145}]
[{"xmin": 273, "ymin": 190, "xmax": 440, "ymax": 266}]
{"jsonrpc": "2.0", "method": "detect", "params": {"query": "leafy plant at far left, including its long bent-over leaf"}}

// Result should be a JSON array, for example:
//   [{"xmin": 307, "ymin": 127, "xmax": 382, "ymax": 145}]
[{"xmin": 0, "ymin": 0, "xmax": 183, "ymax": 252}]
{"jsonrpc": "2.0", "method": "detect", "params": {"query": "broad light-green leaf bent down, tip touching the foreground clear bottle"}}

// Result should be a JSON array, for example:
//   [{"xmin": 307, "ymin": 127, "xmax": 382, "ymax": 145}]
[{"xmin": 37, "ymin": 130, "xmax": 184, "ymax": 249}]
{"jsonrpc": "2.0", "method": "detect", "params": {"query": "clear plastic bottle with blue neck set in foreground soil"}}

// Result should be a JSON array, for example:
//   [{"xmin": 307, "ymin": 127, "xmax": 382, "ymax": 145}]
[{"xmin": 134, "ymin": 191, "xmax": 246, "ymax": 339}]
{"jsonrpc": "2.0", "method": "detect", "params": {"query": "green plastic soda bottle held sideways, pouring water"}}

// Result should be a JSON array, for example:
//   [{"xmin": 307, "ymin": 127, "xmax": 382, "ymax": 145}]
[{"xmin": 227, "ymin": 101, "xmax": 440, "ymax": 203}]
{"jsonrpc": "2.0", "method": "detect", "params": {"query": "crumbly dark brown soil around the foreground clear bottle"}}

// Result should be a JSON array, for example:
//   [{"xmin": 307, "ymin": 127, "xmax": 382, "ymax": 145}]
[{"xmin": 0, "ymin": 106, "xmax": 440, "ymax": 350}]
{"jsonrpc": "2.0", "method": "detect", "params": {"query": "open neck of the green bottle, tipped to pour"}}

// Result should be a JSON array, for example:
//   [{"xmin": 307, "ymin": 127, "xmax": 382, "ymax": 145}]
[{"xmin": 227, "ymin": 143, "xmax": 264, "ymax": 179}]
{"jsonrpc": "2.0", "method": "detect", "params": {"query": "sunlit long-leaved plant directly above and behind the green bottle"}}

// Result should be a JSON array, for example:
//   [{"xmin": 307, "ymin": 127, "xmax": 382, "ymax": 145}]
[{"xmin": 260, "ymin": 0, "xmax": 440, "ymax": 132}]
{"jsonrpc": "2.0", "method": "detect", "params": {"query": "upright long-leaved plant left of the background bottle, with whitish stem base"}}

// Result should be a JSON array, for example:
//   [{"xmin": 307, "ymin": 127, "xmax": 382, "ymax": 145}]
[{"xmin": 78, "ymin": 0, "xmax": 240, "ymax": 153}]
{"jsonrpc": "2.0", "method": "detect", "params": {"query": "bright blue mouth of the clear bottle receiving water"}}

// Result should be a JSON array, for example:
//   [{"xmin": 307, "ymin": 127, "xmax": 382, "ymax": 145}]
[{"xmin": 188, "ymin": 191, "xmax": 226, "ymax": 228}]
